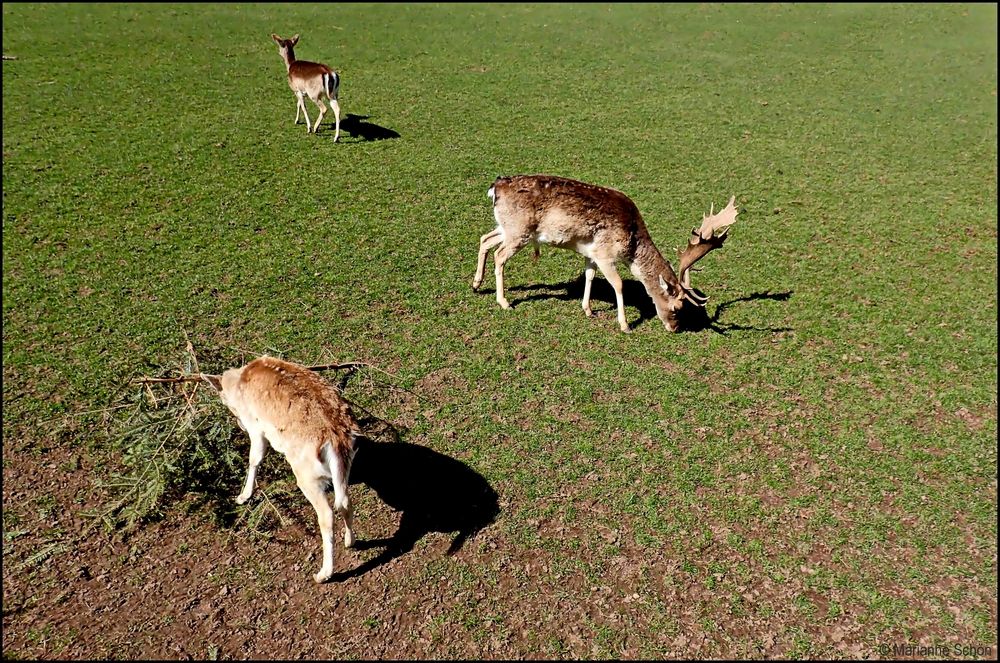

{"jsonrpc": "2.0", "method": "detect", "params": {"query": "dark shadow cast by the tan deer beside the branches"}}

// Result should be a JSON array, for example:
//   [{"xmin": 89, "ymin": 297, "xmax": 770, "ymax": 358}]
[{"xmin": 333, "ymin": 438, "xmax": 500, "ymax": 582}]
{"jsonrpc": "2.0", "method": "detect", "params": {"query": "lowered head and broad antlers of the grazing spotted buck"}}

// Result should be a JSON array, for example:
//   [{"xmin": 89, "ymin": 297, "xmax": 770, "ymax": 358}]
[{"xmin": 654, "ymin": 196, "xmax": 739, "ymax": 331}]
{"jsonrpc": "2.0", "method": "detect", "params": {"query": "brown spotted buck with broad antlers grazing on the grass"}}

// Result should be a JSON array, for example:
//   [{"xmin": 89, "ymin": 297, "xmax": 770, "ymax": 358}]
[{"xmin": 472, "ymin": 175, "xmax": 737, "ymax": 332}]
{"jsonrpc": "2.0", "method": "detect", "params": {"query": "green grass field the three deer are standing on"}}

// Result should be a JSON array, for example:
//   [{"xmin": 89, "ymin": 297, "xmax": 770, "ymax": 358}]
[{"xmin": 3, "ymin": 3, "xmax": 997, "ymax": 658}]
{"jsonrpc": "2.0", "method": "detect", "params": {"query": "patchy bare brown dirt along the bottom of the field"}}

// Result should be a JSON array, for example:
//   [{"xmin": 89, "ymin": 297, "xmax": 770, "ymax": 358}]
[{"xmin": 3, "ymin": 408, "xmax": 996, "ymax": 659}]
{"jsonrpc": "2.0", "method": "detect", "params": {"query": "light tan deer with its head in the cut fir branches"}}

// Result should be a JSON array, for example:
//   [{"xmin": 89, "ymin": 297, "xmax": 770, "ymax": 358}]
[{"xmin": 205, "ymin": 356, "xmax": 361, "ymax": 582}]
